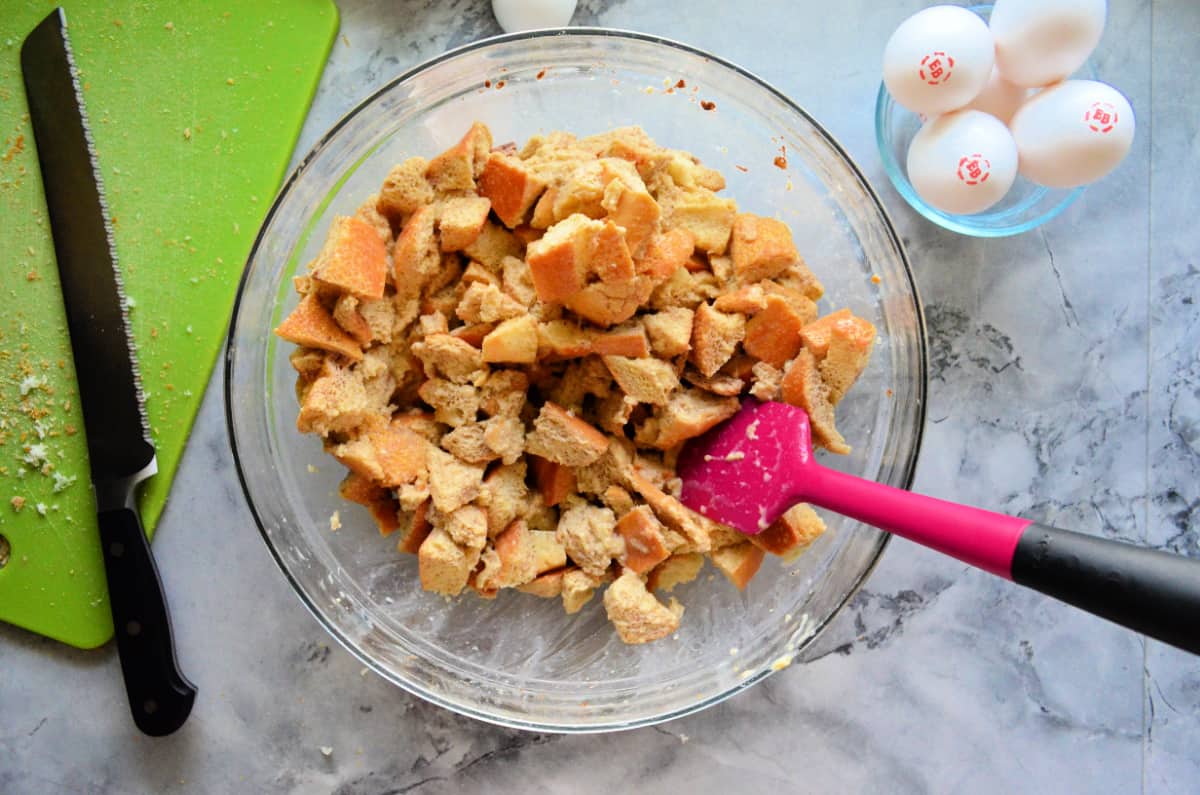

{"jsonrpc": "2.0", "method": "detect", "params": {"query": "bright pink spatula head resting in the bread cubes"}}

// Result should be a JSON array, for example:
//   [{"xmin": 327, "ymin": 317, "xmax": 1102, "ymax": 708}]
[{"xmin": 678, "ymin": 399, "xmax": 812, "ymax": 536}]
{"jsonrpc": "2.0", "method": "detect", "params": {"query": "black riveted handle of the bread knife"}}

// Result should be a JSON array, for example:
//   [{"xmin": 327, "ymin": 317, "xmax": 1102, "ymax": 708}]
[{"xmin": 100, "ymin": 508, "xmax": 196, "ymax": 737}]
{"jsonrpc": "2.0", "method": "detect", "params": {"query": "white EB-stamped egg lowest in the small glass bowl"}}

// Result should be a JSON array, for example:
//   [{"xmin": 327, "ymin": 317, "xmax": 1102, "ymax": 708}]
[{"xmin": 908, "ymin": 110, "xmax": 1016, "ymax": 215}]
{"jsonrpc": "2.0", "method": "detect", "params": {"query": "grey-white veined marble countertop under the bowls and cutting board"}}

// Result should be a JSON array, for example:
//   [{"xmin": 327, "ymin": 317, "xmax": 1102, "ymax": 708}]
[{"xmin": 0, "ymin": 0, "xmax": 1200, "ymax": 795}]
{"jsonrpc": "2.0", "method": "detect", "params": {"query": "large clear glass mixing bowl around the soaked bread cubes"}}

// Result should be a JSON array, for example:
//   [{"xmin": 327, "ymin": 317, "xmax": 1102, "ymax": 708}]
[{"xmin": 226, "ymin": 28, "xmax": 925, "ymax": 731}]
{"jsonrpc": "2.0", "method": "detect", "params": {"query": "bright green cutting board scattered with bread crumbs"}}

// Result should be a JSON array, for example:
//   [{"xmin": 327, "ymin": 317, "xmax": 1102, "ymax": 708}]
[{"xmin": 0, "ymin": 0, "xmax": 337, "ymax": 648}]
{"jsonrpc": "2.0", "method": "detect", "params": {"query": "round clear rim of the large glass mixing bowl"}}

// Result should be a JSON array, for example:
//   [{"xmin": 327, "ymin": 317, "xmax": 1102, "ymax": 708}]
[{"xmin": 229, "ymin": 25, "xmax": 929, "ymax": 734}]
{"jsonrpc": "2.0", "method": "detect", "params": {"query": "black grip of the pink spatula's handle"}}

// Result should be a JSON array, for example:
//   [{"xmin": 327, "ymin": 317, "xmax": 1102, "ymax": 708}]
[{"xmin": 1012, "ymin": 522, "xmax": 1200, "ymax": 654}]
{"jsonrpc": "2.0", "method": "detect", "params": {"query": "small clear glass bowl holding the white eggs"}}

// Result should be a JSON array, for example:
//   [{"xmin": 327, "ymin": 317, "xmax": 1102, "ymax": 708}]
[{"xmin": 875, "ymin": 5, "xmax": 1091, "ymax": 238}]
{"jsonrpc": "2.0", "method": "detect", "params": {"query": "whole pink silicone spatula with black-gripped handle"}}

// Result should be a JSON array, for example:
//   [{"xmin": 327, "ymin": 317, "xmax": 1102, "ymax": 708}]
[{"xmin": 678, "ymin": 400, "xmax": 1200, "ymax": 653}]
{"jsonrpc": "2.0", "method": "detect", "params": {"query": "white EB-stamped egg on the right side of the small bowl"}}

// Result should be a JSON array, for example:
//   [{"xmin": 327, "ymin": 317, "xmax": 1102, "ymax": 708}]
[{"xmin": 1010, "ymin": 80, "xmax": 1135, "ymax": 187}]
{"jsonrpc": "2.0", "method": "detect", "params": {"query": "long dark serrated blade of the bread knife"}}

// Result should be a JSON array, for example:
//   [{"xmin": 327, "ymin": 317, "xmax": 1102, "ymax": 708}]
[{"xmin": 20, "ymin": 8, "xmax": 155, "ymax": 498}]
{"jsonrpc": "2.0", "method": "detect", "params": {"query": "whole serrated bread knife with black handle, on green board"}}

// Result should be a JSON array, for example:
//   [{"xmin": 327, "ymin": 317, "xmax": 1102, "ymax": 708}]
[{"xmin": 20, "ymin": 8, "xmax": 196, "ymax": 736}]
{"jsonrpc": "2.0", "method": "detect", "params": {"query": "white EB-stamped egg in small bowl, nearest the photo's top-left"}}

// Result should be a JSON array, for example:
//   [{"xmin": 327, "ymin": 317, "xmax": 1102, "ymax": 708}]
[{"xmin": 883, "ymin": 6, "xmax": 995, "ymax": 115}]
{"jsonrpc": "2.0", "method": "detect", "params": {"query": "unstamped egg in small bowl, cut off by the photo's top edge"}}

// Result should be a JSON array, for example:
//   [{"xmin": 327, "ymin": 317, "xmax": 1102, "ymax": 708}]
[{"xmin": 989, "ymin": 0, "xmax": 1108, "ymax": 88}]
